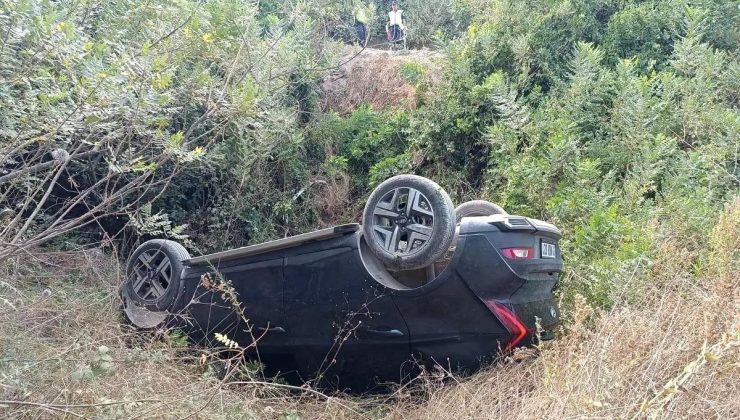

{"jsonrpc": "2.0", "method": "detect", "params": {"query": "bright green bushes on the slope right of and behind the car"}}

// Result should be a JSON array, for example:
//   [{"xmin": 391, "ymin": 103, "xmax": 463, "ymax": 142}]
[{"xmin": 302, "ymin": 0, "xmax": 740, "ymax": 306}]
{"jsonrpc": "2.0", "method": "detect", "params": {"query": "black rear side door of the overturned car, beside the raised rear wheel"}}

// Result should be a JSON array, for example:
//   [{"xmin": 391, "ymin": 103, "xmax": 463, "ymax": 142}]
[{"xmin": 285, "ymin": 247, "xmax": 410, "ymax": 389}]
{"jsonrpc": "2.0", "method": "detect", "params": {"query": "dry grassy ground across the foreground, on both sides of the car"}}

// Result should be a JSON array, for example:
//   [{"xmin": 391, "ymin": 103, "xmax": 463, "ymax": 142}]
[{"xmin": 0, "ymin": 202, "xmax": 740, "ymax": 419}]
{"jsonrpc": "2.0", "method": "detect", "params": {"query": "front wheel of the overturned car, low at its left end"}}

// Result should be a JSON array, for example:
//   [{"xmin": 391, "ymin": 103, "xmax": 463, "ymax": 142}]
[{"xmin": 122, "ymin": 239, "xmax": 190, "ymax": 311}]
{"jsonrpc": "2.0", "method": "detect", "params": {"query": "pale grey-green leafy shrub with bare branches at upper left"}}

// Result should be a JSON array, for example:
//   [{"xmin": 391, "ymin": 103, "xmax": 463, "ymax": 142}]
[{"xmin": 0, "ymin": 0, "xmax": 333, "ymax": 259}]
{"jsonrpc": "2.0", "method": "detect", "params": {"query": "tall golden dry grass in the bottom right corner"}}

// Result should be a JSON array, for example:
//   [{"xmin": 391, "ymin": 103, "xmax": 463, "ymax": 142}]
[{"xmin": 393, "ymin": 201, "xmax": 740, "ymax": 419}]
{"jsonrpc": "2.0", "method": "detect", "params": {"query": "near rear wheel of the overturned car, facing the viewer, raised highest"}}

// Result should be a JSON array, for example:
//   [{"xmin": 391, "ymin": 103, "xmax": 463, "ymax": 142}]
[{"xmin": 362, "ymin": 175, "xmax": 455, "ymax": 270}]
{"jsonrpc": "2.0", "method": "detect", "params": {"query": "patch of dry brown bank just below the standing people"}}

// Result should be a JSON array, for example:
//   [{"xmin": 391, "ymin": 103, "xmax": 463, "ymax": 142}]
[{"xmin": 321, "ymin": 49, "xmax": 441, "ymax": 115}]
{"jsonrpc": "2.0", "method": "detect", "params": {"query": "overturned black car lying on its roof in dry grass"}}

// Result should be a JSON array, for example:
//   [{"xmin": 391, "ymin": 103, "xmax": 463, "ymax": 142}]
[{"xmin": 121, "ymin": 175, "xmax": 562, "ymax": 389}]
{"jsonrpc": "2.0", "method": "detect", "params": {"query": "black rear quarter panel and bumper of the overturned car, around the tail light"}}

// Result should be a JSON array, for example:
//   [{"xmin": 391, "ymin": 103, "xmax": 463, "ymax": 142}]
[{"xmin": 393, "ymin": 226, "xmax": 562, "ymax": 370}]
